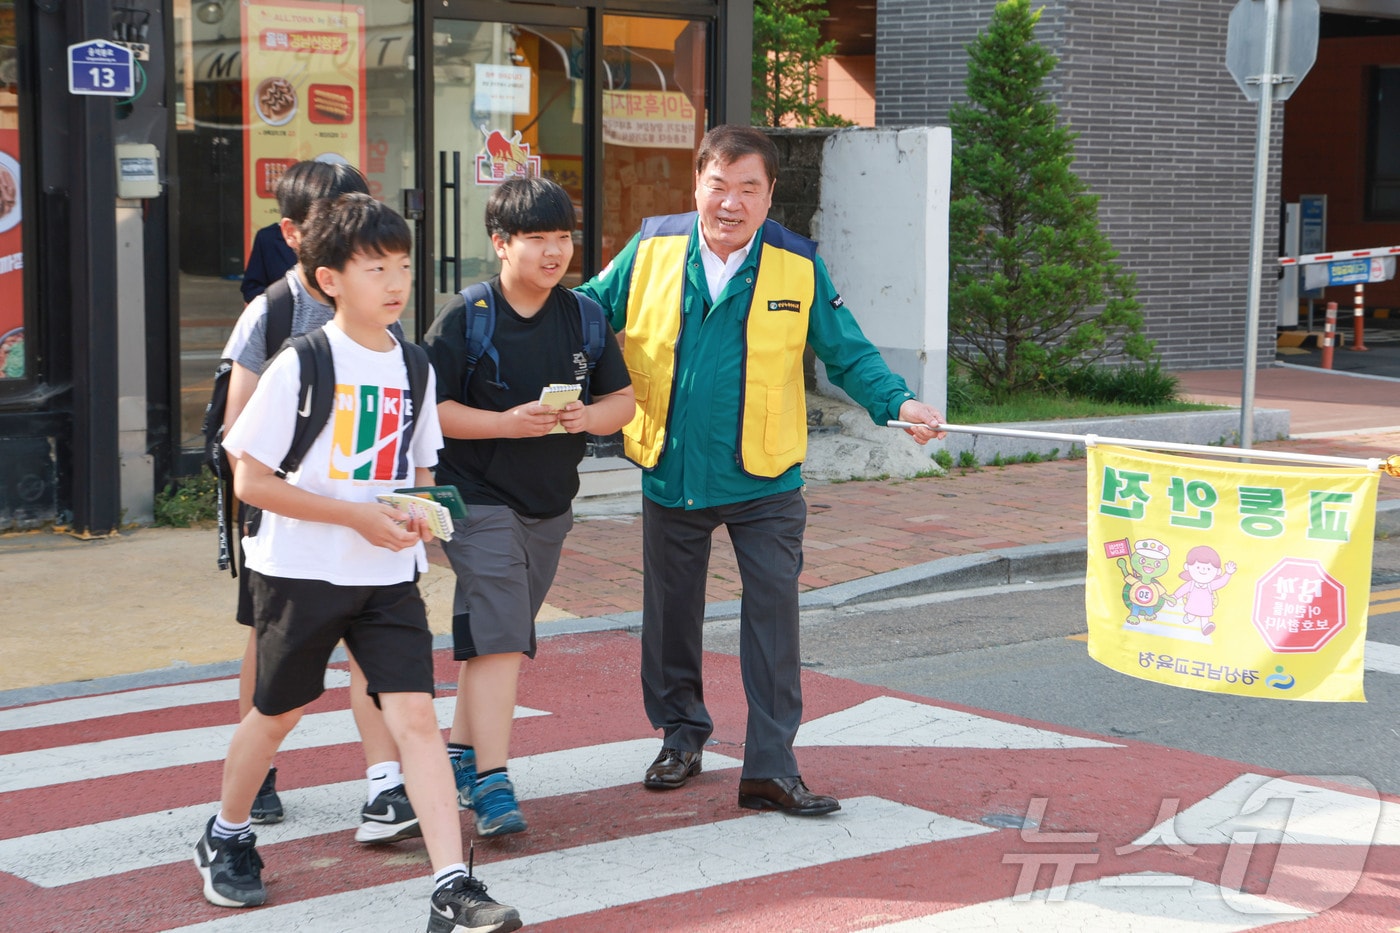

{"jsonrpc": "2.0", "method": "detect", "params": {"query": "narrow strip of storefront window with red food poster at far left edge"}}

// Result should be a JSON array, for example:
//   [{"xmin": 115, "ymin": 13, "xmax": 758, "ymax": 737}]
[{"xmin": 0, "ymin": 3, "xmax": 28, "ymax": 380}]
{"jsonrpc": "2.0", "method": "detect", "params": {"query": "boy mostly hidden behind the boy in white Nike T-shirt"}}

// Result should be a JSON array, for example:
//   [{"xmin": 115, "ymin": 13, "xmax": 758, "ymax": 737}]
[{"xmin": 212, "ymin": 161, "xmax": 419, "ymax": 845}]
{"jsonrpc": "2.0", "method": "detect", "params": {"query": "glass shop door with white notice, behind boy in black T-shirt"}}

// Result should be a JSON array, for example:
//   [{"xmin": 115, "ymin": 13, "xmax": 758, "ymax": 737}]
[{"xmin": 426, "ymin": 4, "xmax": 588, "ymax": 319}]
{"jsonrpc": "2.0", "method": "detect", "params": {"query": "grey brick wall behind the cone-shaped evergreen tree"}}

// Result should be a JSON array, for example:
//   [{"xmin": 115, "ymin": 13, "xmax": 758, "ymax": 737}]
[{"xmin": 875, "ymin": 0, "xmax": 1282, "ymax": 370}]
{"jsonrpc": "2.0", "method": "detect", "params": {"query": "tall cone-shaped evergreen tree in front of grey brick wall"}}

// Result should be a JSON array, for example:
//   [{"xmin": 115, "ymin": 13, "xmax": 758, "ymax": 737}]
[{"xmin": 948, "ymin": 0, "xmax": 1154, "ymax": 398}]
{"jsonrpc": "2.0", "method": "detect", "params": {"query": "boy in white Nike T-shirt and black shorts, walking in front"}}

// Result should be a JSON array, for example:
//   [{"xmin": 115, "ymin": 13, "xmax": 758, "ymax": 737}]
[{"xmin": 195, "ymin": 195, "xmax": 521, "ymax": 933}]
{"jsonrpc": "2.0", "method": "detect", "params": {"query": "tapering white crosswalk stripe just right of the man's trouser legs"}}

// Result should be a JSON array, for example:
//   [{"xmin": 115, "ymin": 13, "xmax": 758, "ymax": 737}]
[{"xmin": 797, "ymin": 696, "xmax": 1121, "ymax": 748}]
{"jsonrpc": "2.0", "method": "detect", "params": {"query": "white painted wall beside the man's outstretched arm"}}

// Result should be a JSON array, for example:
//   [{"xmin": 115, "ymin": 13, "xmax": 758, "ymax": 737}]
[{"xmin": 812, "ymin": 126, "xmax": 952, "ymax": 412}]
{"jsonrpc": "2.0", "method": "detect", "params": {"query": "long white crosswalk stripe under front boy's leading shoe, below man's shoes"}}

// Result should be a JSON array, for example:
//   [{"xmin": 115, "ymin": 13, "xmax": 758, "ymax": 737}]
[{"xmin": 161, "ymin": 797, "xmax": 994, "ymax": 933}]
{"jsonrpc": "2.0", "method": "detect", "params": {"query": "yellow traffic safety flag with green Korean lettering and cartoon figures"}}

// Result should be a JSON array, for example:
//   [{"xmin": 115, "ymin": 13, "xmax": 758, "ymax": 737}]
[{"xmin": 1085, "ymin": 445, "xmax": 1379, "ymax": 702}]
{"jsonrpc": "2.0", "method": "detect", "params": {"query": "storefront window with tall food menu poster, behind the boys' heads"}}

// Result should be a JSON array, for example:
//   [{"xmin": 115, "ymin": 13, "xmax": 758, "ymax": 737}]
[{"xmin": 174, "ymin": 0, "xmax": 414, "ymax": 447}]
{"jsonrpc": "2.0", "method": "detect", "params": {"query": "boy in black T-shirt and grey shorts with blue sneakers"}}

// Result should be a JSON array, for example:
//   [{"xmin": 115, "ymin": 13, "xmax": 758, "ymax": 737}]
[{"xmin": 424, "ymin": 178, "xmax": 636, "ymax": 836}]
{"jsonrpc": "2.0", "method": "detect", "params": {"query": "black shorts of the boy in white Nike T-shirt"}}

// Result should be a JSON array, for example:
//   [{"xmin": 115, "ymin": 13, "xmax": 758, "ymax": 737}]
[{"xmin": 248, "ymin": 570, "xmax": 434, "ymax": 716}]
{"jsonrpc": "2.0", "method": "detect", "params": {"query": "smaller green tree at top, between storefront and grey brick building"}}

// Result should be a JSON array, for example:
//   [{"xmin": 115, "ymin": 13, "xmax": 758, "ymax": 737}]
[{"xmin": 753, "ymin": 0, "xmax": 850, "ymax": 126}]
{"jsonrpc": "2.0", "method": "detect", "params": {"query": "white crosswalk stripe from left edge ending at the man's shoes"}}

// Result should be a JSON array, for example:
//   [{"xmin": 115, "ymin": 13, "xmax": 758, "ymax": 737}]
[{"xmin": 0, "ymin": 738, "xmax": 742, "ymax": 888}]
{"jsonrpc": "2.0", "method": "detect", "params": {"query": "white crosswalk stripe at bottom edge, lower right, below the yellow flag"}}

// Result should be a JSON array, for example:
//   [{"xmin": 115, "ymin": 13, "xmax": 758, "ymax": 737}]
[{"xmin": 865, "ymin": 873, "xmax": 1313, "ymax": 933}]
